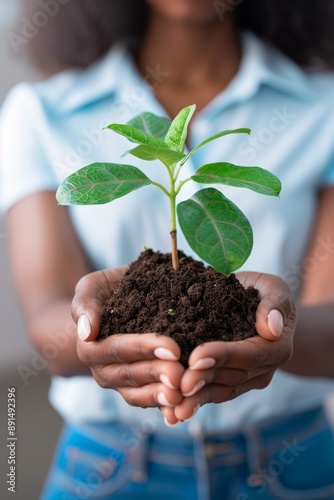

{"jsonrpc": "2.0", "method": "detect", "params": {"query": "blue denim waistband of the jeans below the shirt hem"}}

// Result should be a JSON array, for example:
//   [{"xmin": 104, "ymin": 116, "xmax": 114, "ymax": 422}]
[{"xmin": 70, "ymin": 407, "xmax": 328, "ymax": 466}]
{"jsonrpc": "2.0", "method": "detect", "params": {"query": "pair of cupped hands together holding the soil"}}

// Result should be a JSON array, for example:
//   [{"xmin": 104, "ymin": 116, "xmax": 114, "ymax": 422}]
[{"xmin": 72, "ymin": 266, "xmax": 296, "ymax": 425}]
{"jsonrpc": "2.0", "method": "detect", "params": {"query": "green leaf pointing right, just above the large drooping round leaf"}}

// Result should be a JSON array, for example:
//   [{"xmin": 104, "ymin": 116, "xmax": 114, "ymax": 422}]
[{"xmin": 191, "ymin": 163, "xmax": 282, "ymax": 196}]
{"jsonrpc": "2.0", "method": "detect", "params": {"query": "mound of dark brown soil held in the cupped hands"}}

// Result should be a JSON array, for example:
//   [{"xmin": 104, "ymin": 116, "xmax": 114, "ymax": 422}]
[{"xmin": 99, "ymin": 250, "xmax": 259, "ymax": 367}]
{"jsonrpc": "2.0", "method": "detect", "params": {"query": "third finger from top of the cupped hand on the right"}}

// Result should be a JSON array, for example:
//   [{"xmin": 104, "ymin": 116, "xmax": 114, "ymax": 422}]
[{"xmin": 174, "ymin": 371, "xmax": 274, "ymax": 421}]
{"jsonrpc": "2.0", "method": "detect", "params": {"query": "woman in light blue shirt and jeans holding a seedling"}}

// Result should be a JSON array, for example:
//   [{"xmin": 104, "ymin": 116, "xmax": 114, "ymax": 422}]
[{"xmin": 0, "ymin": 0, "xmax": 334, "ymax": 500}]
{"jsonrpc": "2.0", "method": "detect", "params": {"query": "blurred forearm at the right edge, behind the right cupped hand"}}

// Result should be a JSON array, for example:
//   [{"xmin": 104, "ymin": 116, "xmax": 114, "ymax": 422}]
[{"xmin": 282, "ymin": 304, "xmax": 334, "ymax": 378}]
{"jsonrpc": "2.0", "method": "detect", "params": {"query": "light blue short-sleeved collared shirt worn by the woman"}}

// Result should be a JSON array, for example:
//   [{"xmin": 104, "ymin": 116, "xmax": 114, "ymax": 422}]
[{"xmin": 0, "ymin": 34, "xmax": 334, "ymax": 432}]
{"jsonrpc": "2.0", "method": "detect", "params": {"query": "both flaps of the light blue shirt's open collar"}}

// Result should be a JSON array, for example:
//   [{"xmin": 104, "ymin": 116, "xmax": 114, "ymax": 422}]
[{"xmin": 53, "ymin": 32, "xmax": 318, "ymax": 113}]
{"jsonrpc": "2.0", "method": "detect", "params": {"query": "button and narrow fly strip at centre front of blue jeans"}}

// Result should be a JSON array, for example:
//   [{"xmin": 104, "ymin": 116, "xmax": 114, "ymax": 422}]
[{"xmin": 189, "ymin": 421, "xmax": 210, "ymax": 500}]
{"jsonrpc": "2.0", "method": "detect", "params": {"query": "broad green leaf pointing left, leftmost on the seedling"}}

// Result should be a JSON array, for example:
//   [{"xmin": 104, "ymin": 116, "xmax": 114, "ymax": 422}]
[{"xmin": 56, "ymin": 163, "xmax": 152, "ymax": 205}]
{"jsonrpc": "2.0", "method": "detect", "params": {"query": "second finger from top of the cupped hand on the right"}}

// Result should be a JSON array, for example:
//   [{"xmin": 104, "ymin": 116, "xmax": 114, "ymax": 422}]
[{"xmin": 180, "ymin": 366, "xmax": 272, "ymax": 397}]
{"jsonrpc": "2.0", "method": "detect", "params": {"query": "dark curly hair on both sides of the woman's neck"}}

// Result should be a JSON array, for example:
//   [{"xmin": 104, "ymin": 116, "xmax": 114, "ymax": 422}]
[{"xmin": 23, "ymin": 0, "xmax": 334, "ymax": 69}]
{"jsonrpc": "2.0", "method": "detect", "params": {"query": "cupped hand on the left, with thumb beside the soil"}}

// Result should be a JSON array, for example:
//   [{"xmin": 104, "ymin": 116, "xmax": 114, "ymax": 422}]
[{"xmin": 72, "ymin": 266, "xmax": 184, "ymax": 408}]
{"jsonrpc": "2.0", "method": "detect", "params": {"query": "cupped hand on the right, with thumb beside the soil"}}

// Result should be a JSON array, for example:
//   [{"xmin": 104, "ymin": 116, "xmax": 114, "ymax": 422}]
[{"xmin": 163, "ymin": 272, "xmax": 296, "ymax": 424}]
